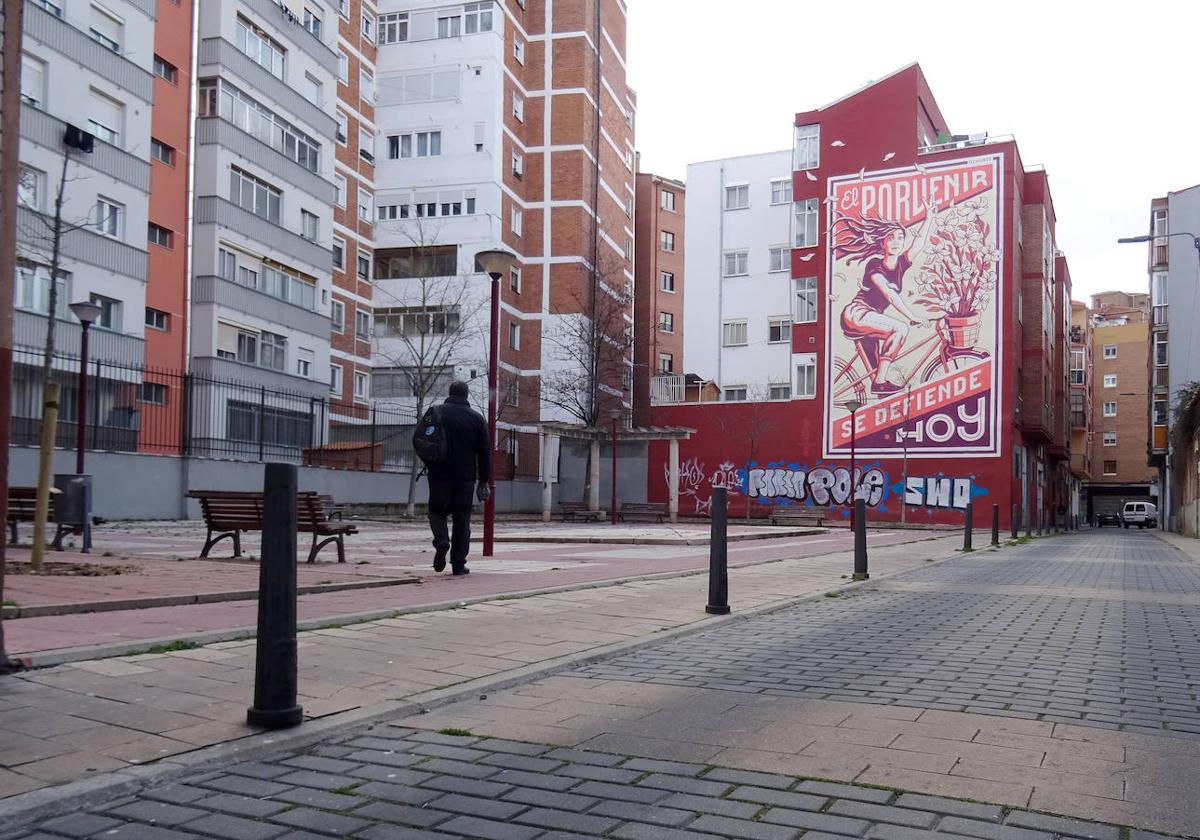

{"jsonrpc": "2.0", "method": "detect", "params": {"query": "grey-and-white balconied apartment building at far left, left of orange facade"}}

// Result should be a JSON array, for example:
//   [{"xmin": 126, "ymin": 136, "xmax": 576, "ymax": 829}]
[{"xmin": 13, "ymin": 0, "xmax": 157, "ymax": 448}]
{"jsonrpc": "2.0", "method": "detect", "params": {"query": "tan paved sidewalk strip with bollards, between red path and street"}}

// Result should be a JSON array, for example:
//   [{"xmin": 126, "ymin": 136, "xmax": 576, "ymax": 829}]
[{"xmin": 0, "ymin": 534, "xmax": 961, "ymax": 797}]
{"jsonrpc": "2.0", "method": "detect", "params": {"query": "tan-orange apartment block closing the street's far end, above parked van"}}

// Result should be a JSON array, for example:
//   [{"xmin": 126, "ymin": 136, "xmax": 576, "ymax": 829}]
[{"xmin": 1088, "ymin": 292, "xmax": 1153, "ymax": 521}]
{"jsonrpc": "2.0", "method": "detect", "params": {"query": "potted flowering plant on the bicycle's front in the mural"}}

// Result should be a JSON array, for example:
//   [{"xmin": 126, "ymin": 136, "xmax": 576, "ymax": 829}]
[{"xmin": 917, "ymin": 198, "xmax": 1000, "ymax": 352}]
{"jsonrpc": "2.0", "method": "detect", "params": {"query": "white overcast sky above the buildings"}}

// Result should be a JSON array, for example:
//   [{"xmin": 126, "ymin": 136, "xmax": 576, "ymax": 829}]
[{"xmin": 628, "ymin": 0, "xmax": 1200, "ymax": 300}]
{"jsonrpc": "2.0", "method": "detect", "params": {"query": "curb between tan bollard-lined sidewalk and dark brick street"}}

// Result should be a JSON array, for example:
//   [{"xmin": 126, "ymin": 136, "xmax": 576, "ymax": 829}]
[{"xmin": 0, "ymin": 530, "xmax": 984, "ymax": 828}]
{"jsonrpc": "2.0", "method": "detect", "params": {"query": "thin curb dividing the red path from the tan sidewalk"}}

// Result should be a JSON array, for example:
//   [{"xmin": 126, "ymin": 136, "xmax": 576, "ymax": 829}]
[{"xmin": 10, "ymin": 534, "xmax": 952, "ymax": 668}]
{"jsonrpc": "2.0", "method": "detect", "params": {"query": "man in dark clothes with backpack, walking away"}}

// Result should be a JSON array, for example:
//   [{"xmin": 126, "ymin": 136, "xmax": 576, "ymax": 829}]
[{"xmin": 427, "ymin": 382, "xmax": 492, "ymax": 575}]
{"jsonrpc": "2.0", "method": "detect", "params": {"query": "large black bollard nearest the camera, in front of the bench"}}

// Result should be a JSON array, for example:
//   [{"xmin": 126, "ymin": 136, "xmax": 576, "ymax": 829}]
[{"xmin": 246, "ymin": 463, "xmax": 304, "ymax": 730}]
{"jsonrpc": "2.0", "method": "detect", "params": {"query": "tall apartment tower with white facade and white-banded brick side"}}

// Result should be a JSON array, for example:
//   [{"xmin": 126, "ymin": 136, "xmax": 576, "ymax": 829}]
[{"xmin": 373, "ymin": 0, "xmax": 636, "ymax": 475}]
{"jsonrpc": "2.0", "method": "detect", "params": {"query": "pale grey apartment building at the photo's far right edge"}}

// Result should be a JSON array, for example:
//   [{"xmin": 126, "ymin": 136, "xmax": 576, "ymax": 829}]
[{"xmin": 1128, "ymin": 185, "xmax": 1200, "ymax": 530}]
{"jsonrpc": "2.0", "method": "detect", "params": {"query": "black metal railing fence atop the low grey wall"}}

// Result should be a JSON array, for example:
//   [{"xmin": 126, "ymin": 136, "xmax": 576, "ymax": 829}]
[{"xmin": 11, "ymin": 349, "xmax": 415, "ymax": 472}]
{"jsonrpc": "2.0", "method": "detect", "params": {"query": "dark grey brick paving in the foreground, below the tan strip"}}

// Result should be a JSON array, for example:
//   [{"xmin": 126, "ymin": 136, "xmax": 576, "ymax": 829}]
[{"xmin": 0, "ymin": 726, "xmax": 1185, "ymax": 840}]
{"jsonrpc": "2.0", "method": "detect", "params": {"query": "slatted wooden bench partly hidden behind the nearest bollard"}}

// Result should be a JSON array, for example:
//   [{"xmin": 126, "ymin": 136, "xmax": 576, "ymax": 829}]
[{"xmin": 187, "ymin": 490, "xmax": 359, "ymax": 563}]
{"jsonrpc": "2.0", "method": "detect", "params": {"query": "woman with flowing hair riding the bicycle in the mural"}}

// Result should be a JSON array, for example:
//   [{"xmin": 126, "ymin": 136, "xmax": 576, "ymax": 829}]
[{"xmin": 834, "ymin": 203, "xmax": 937, "ymax": 395}]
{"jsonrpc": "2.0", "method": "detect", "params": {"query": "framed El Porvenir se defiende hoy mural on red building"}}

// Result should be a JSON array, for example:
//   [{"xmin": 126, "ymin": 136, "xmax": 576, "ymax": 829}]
[{"xmin": 823, "ymin": 155, "xmax": 1003, "ymax": 457}]
